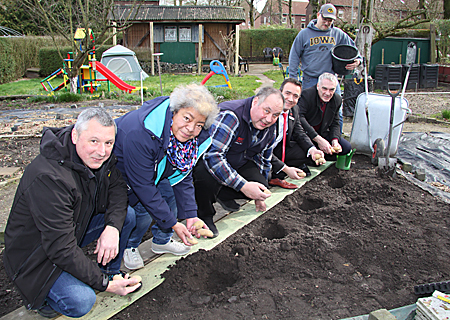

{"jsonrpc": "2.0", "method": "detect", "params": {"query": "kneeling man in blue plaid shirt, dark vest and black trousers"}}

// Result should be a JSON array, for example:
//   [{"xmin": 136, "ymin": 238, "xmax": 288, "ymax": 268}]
[{"xmin": 194, "ymin": 87, "xmax": 284, "ymax": 236}]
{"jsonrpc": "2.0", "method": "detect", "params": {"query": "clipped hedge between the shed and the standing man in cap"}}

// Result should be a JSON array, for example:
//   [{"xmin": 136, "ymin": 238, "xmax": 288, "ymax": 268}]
[{"xmin": 239, "ymin": 28, "xmax": 299, "ymax": 57}]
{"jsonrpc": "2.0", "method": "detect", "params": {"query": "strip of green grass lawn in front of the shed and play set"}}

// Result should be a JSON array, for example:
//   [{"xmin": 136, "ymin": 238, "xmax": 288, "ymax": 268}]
[{"xmin": 0, "ymin": 74, "xmax": 260, "ymax": 103}]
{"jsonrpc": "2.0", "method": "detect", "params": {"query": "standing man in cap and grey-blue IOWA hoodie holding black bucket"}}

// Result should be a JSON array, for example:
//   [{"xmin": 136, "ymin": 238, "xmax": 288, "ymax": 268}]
[{"xmin": 289, "ymin": 3, "xmax": 362, "ymax": 131}]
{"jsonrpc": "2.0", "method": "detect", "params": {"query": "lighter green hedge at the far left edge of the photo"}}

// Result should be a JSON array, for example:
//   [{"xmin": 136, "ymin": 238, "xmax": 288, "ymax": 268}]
[{"xmin": 0, "ymin": 36, "xmax": 69, "ymax": 84}]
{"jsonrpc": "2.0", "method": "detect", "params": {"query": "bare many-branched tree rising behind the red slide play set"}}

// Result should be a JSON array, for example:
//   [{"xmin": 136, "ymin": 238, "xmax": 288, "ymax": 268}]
[{"xmin": 20, "ymin": 0, "xmax": 142, "ymax": 92}]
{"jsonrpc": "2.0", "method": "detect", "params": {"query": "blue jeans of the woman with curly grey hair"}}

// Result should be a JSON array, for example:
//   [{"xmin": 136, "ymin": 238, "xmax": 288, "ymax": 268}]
[{"xmin": 127, "ymin": 179, "xmax": 178, "ymax": 248}]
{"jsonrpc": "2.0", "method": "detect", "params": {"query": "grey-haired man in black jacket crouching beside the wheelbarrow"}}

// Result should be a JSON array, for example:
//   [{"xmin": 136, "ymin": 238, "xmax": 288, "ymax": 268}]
[{"xmin": 298, "ymin": 72, "xmax": 352, "ymax": 160}]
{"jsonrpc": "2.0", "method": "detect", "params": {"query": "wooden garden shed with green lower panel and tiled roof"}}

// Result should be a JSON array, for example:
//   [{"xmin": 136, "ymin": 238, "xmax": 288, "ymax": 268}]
[{"xmin": 114, "ymin": 4, "xmax": 245, "ymax": 64}]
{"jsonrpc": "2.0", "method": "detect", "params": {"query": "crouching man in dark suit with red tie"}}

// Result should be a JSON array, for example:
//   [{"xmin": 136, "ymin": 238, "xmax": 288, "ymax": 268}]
[{"xmin": 269, "ymin": 78, "xmax": 323, "ymax": 189}]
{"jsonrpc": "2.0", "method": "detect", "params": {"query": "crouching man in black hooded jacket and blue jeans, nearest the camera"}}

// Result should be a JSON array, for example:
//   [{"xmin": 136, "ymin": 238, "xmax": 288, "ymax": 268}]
[{"xmin": 3, "ymin": 108, "xmax": 140, "ymax": 317}]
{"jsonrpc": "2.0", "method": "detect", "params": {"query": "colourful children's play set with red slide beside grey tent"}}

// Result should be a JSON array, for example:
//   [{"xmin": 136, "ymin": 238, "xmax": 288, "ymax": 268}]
[{"xmin": 41, "ymin": 28, "xmax": 144, "ymax": 93}]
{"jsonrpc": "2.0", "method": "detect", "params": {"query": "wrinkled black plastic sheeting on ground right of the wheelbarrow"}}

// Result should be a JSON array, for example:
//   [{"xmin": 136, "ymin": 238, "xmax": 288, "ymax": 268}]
[{"xmin": 397, "ymin": 132, "xmax": 450, "ymax": 187}]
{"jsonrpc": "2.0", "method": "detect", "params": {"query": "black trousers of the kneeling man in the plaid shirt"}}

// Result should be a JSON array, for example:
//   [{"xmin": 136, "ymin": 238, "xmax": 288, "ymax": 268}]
[{"xmin": 192, "ymin": 160, "xmax": 269, "ymax": 218}]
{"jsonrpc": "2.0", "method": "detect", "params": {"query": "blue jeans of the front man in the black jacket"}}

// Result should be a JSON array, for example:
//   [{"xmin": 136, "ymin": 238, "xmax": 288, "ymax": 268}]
[{"xmin": 46, "ymin": 211, "xmax": 136, "ymax": 318}]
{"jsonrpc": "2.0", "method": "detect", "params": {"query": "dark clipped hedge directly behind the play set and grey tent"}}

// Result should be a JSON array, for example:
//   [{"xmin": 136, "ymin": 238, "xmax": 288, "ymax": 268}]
[{"xmin": 39, "ymin": 46, "xmax": 112, "ymax": 77}]
